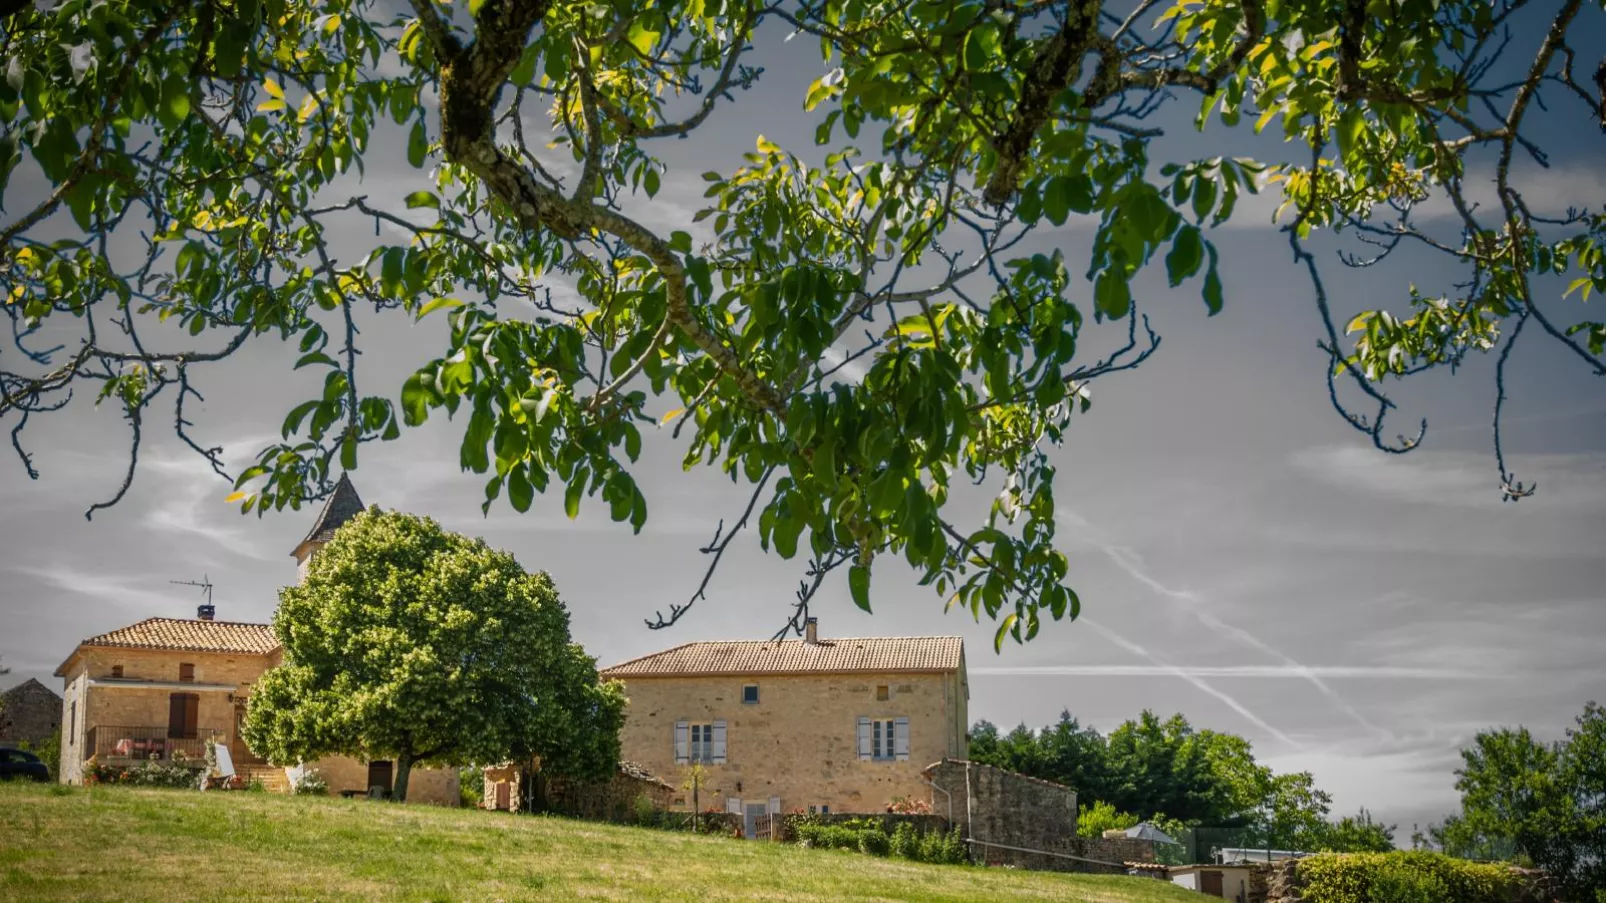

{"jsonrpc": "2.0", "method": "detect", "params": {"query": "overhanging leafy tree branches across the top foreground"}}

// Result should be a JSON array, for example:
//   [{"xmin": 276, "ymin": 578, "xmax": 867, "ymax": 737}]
[{"xmin": 0, "ymin": 0, "xmax": 1606, "ymax": 641}]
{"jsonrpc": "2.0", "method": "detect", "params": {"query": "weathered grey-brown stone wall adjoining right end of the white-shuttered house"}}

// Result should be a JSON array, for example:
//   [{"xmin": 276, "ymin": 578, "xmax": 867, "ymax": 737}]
[{"xmin": 925, "ymin": 758, "xmax": 1155, "ymax": 874}]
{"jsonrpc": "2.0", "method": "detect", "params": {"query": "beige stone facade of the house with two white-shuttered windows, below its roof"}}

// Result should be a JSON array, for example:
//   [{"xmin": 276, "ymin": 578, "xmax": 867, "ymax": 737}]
[{"xmin": 620, "ymin": 670, "xmax": 963, "ymax": 813}]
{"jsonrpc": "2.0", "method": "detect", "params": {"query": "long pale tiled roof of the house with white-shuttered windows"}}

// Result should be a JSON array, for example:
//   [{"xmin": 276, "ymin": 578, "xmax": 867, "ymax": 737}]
[{"xmin": 602, "ymin": 636, "xmax": 965, "ymax": 678}]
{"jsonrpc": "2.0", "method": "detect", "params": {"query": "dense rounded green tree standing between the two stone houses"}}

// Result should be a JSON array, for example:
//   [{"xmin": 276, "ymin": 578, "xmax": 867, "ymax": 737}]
[{"xmin": 244, "ymin": 508, "xmax": 625, "ymax": 799}]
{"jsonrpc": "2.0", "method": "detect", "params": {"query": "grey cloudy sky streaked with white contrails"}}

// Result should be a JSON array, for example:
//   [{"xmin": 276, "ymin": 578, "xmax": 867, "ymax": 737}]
[{"xmin": 0, "ymin": 5, "xmax": 1606, "ymax": 834}]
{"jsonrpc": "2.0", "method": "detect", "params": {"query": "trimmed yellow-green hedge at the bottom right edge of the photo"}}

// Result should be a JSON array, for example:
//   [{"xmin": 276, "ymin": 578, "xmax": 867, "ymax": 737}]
[{"xmin": 1296, "ymin": 852, "xmax": 1519, "ymax": 903}]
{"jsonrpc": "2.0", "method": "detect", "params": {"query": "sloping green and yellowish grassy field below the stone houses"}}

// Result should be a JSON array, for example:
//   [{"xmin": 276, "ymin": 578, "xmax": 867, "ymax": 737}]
[{"xmin": 0, "ymin": 784, "xmax": 1198, "ymax": 903}]
